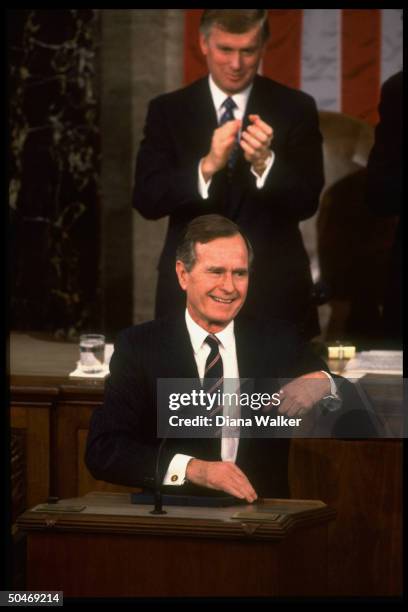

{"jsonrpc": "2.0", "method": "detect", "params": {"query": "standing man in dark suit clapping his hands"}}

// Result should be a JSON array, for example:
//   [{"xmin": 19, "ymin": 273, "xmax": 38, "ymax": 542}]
[{"xmin": 133, "ymin": 9, "xmax": 323, "ymax": 338}]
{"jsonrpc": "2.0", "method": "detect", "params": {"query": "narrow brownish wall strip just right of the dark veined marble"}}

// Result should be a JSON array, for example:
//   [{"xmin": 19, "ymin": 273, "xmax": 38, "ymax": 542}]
[{"xmin": 100, "ymin": 9, "xmax": 134, "ymax": 334}]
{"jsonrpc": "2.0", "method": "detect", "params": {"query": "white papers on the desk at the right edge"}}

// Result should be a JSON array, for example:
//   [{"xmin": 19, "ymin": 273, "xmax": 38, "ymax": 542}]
[{"xmin": 342, "ymin": 351, "xmax": 402, "ymax": 379}]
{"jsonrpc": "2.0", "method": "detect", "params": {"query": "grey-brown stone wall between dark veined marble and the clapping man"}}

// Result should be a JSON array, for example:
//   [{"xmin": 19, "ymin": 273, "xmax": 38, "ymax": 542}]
[{"xmin": 100, "ymin": 9, "xmax": 184, "ymax": 332}]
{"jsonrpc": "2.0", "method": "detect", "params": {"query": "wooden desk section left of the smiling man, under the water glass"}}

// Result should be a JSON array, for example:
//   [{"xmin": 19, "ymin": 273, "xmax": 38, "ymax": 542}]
[{"xmin": 10, "ymin": 333, "xmax": 133, "ymax": 510}]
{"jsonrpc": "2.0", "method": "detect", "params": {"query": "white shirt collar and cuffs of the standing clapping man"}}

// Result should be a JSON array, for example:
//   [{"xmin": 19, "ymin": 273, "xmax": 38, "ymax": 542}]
[{"xmin": 198, "ymin": 75, "xmax": 275, "ymax": 200}]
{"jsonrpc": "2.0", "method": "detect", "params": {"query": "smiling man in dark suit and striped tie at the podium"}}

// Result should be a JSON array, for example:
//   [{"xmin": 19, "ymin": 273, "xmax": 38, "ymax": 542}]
[{"xmin": 86, "ymin": 215, "xmax": 339, "ymax": 502}]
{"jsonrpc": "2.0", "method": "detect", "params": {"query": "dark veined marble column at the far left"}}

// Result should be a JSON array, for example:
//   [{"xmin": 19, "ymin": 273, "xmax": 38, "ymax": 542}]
[{"xmin": 7, "ymin": 9, "xmax": 100, "ymax": 338}]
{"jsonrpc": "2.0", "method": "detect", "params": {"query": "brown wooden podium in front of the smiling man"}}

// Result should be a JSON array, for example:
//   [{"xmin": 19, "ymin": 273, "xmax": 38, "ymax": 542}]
[{"xmin": 18, "ymin": 493, "xmax": 335, "ymax": 597}]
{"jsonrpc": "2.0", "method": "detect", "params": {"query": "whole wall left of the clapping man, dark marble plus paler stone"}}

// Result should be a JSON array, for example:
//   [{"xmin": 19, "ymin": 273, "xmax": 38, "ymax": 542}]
[{"xmin": 8, "ymin": 9, "xmax": 184, "ymax": 338}]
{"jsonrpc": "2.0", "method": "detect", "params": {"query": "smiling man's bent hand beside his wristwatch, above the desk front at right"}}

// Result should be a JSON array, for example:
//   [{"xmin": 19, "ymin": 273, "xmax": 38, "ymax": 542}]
[{"xmin": 278, "ymin": 372, "xmax": 330, "ymax": 417}]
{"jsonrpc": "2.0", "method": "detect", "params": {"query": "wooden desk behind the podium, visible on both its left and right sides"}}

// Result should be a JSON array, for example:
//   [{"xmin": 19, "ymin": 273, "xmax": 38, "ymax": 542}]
[{"xmin": 11, "ymin": 338, "xmax": 402, "ymax": 596}]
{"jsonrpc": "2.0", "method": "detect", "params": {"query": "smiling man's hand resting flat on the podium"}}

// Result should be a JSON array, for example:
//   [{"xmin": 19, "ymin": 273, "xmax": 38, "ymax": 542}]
[{"xmin": 186, "ymin": 459, "xmax": 258, "ymax": 503}]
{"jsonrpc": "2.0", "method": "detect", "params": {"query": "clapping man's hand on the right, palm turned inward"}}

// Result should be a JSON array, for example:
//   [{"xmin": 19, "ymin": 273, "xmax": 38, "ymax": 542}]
[{"xmin": 240, "ymin": 115, "xmax": 273, "ymax": 176}]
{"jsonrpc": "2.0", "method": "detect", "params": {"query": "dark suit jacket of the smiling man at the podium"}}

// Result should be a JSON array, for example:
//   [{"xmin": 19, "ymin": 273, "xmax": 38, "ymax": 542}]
[{"xmin": 86, "ymin": 313, "xmax": 334, "ymax": 497}]
